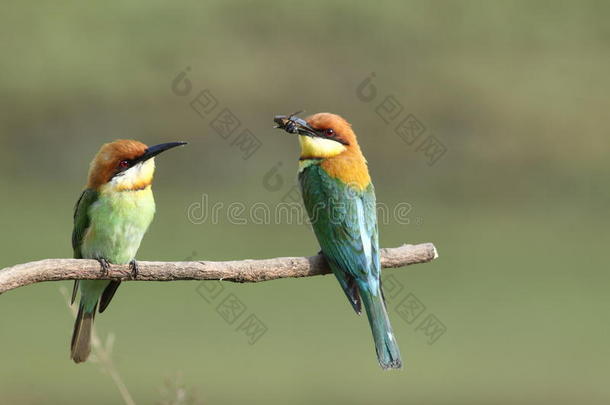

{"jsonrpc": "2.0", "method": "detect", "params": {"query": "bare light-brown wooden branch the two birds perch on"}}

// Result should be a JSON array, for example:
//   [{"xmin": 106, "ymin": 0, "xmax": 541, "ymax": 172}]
[{"xmin": 0, "ymin": 243, "xmax": 438, "ymax": 294}]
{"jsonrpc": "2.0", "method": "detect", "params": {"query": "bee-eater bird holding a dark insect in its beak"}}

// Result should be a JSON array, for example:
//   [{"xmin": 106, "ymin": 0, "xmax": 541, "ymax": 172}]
[{"xmin": 274, "ymin": 113, "xmax": 402, "ymax": 369}]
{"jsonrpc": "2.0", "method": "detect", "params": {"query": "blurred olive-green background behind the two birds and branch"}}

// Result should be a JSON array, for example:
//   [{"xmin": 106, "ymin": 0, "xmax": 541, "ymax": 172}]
[{"xmin": 0, "ymin": 0, "xmax": 610, "ymax": 404}]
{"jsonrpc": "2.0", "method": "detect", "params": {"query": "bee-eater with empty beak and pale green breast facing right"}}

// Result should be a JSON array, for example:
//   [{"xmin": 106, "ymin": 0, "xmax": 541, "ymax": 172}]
[{"xmin": 70, "ymin": 140, "xmax": 186, "ymax": 363}]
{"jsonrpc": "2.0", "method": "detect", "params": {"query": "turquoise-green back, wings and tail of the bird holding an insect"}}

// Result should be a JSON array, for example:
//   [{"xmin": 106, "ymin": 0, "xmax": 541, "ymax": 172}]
[{"xmin": 299, "ymin": 164, "xmax": 402, "ymax": 369}]
